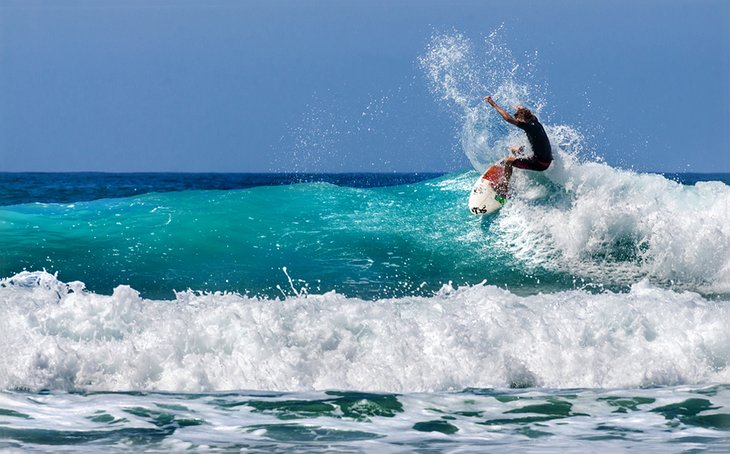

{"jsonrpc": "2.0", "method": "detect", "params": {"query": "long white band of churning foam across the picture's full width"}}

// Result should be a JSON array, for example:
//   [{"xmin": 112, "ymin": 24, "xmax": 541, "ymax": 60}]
[{"xmin": 0, "ymin": 272, "xmax": 730, "ymax": 392}]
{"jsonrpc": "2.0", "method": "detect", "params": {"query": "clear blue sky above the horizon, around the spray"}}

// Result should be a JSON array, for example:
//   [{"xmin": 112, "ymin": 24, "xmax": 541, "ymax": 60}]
[{"xmin": 0, "ymin": 0, "xmax": 730, "ymax": 172}]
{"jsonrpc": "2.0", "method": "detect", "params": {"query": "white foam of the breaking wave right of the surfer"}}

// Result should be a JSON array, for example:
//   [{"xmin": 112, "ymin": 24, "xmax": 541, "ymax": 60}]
[{"xmin": 495, "ymin": 152, "xmax": 730, "ymax": 293}]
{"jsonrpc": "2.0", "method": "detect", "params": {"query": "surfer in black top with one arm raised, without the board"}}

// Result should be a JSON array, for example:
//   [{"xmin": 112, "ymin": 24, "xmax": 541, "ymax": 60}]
[{"xmin": 484, "ymin": 96, "xmax": 553, "ymax": 193}]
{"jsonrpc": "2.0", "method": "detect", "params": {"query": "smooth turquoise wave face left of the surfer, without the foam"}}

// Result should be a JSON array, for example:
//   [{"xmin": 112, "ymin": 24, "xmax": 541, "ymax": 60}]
[{"xmin": 0, "ymin": 174, "xmax": 560, "ymax": 298}]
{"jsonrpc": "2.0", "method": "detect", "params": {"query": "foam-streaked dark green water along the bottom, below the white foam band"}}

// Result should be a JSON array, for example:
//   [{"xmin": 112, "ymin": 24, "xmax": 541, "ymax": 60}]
[{"xmin": 0, "ymin": 385, "xmax": 730, "ymax": 454}]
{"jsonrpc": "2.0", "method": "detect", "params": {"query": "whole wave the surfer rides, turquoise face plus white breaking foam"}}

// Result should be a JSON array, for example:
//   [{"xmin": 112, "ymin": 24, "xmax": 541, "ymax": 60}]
[{"xmin": 0, "ymin": 160, "xmax": 730, "ymax": 299}]
